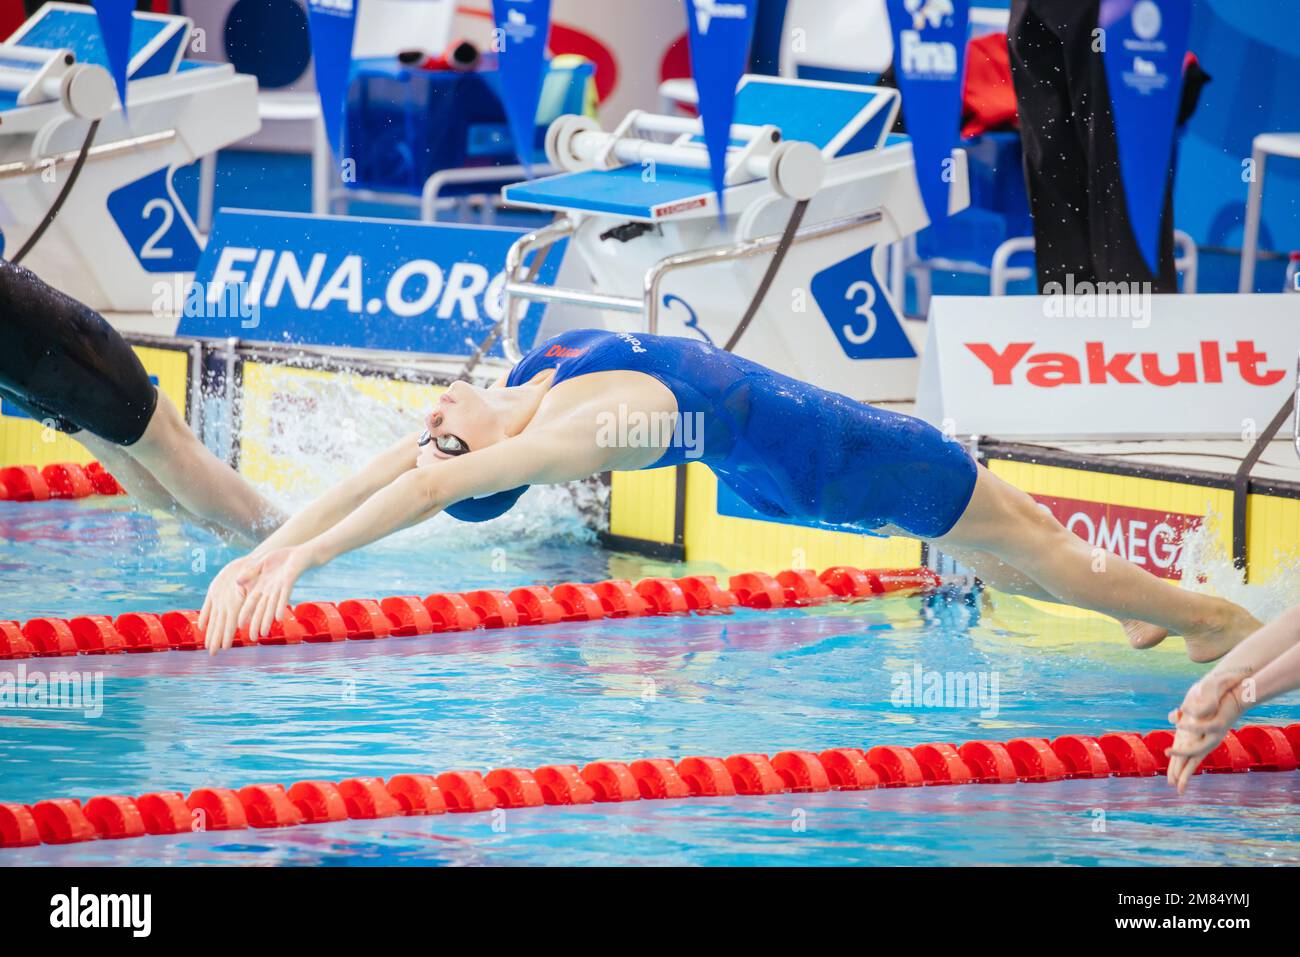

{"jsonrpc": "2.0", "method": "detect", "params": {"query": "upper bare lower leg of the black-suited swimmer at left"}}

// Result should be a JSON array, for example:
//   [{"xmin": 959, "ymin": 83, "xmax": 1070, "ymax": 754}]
[{"xmin": 122, "ymin": 391, "xmax": 285, "ymax": 541}]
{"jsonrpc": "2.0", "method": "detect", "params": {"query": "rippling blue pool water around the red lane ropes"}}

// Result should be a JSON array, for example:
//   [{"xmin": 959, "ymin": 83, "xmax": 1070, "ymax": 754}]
[{"xmin": 0, "ymin": 493, "xmax": 1300, "ymax": 866}]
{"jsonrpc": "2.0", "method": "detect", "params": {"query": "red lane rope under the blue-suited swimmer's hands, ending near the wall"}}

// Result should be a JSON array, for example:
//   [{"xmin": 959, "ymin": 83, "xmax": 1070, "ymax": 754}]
[{"xmin": 0, "ymin": 564, "xmax": 941, "ymax": 661}]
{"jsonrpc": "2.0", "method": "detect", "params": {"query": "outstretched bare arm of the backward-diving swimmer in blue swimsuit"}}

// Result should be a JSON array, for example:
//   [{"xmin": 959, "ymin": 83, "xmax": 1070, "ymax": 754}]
[{"xmin": 202, "ymin": 425, "xmax": 613, "ymax": 654}]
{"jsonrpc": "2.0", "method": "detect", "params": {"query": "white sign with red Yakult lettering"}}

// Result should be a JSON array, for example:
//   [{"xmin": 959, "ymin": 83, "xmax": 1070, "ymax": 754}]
[{"xmin": 917, "ymin": 295, "xmax": 1300, "ymax": 438}]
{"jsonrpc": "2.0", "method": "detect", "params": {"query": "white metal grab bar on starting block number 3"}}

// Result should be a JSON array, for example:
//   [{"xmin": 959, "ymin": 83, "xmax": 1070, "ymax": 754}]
[{"xmin": 502, "ymin": 209, "xmax": 884, "ymax": 363}]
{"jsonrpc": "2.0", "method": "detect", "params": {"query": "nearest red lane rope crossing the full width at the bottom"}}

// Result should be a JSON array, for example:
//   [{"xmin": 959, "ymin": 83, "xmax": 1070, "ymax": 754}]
[{"xmin": 0, "ymin": 724, "xmax": 1300, "ymax": 848}]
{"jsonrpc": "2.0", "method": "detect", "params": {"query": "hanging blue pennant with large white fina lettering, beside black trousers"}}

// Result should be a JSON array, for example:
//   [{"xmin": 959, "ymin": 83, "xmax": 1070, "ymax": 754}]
[{"xmin": 887, "ymin": 0, "xmax": 970, "ymax": 222}]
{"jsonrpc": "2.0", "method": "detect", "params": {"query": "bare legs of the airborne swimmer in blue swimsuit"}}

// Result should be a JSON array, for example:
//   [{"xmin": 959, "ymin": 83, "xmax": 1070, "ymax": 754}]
[{"xmin": 936, "ymin": 467, "xmax": 1260, "ymax": 662}]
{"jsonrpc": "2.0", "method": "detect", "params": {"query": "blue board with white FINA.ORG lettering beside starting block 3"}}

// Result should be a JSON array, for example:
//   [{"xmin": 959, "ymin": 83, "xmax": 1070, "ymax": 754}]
[{"xmin": 182, "ymin": 209, "xmax": 564, "ymax": 355}]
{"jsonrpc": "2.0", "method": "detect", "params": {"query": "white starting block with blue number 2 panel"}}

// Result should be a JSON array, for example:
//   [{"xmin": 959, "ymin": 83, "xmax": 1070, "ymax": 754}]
[{"xmin": 0, "ymin": 3, "xmax": 259, "ymax": 312}]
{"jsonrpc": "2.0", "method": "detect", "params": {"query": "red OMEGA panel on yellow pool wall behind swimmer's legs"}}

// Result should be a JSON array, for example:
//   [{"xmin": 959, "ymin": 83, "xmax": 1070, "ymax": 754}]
[{"xmin": 1034, "ymin": 495, "xmax": 1205, "ymax": 580}]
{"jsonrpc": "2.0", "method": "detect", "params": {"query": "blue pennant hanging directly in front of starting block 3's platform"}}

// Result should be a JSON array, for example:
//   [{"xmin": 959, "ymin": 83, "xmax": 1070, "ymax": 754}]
[{"xmin": 685, "ymin": 0, "xmax": 758, "ymax": 217}]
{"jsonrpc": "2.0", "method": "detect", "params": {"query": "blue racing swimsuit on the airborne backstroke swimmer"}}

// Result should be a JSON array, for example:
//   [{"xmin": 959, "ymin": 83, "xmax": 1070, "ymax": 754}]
[{"xmin": 488, "ymin": 329, "xmax": 975, "ymax": 538}]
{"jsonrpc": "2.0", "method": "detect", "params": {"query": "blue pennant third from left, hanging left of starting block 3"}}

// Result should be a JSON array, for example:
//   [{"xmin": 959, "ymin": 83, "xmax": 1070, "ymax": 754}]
[{"xmin": 491, "ymin": 0, "xmax": 551, "ymax": 176}]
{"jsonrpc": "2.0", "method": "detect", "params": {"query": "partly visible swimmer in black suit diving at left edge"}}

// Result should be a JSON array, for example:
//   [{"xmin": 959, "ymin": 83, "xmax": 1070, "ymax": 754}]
[{"xmin": 0, "ymin": 260, "xmax": 283, "ymax": 542}]
